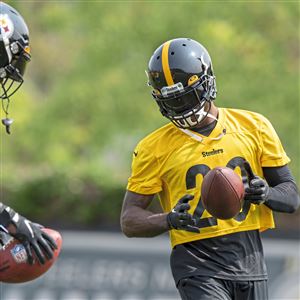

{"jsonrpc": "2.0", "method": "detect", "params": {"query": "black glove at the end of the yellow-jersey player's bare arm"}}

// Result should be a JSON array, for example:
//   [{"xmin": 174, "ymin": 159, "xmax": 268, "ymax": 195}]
[{"xmin": 167, "ymin": 195, "xmax": 200, "ymax": 233}]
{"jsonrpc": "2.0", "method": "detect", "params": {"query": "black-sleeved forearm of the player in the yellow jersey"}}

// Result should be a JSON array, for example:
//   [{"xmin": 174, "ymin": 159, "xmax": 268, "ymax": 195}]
[{"xmin": 265, "ymin": 181, "xmax": 300, "ymax": 213}]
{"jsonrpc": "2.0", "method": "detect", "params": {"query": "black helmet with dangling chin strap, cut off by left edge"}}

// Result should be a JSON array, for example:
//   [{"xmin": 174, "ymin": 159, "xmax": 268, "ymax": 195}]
[{"xmin": 0, "ymin": 2, "xmax": 31, "ymax": 132}]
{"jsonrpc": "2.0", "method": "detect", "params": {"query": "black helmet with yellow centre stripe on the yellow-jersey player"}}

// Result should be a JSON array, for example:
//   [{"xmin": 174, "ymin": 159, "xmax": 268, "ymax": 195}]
[{"xmin": 147, "ymin": 38, "xmax": 217, "ymax": 128}]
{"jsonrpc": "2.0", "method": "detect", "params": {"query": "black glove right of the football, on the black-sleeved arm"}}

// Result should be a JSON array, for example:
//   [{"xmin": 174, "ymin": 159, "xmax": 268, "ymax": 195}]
[{"xmin": 244, "ymin": 161, "xmax": 270, "ymax": 205}]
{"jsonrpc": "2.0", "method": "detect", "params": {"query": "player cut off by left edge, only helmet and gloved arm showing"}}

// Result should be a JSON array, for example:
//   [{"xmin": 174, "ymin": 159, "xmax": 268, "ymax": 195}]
[{"xmin": 0, "ymin": 2, "xmax": 57, "ymax": 264}]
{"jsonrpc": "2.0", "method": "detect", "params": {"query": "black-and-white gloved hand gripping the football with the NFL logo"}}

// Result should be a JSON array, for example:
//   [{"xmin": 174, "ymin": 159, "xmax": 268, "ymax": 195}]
[{"xmin": 9, "ymin": 213, "xmax": 57, "ymax": 265}]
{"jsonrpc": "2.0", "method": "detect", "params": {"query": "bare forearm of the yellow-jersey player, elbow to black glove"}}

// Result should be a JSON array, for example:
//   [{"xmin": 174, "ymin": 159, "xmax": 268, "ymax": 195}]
[{"xmin": 121, "ymin": 207, "xmax": 169, "ymax": 237}]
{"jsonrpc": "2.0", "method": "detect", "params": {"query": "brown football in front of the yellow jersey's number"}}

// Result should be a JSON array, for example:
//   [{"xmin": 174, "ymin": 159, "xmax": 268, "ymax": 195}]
[{"xmin": 201, "ymin": 167, "xmax": 245, "ymax": 220}]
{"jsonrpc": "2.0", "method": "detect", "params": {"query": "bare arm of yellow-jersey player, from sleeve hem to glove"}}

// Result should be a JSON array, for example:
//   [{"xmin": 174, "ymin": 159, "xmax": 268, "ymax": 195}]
[{"xmin": 121, "ymin": 191, "xmax": 169, "ymax": 237}]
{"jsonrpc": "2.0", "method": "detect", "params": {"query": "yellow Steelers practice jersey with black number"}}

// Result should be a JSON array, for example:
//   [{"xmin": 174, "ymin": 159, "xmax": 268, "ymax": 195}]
[{"xmin": 127, "ymin": 108, "xmax": 290, "ymax": 247}]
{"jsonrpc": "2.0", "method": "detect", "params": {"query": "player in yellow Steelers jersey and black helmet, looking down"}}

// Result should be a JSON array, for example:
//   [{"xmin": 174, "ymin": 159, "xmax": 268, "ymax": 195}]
[{"xmin": 121, "ymin": 38, "xmax": 300, "ymax": 300}]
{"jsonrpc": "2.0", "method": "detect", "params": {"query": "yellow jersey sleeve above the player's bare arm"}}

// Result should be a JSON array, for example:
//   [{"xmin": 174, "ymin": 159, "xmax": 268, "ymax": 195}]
[{"xmin": 127, "ymin": 143, "xmax": 162, "ymax": 195}]
